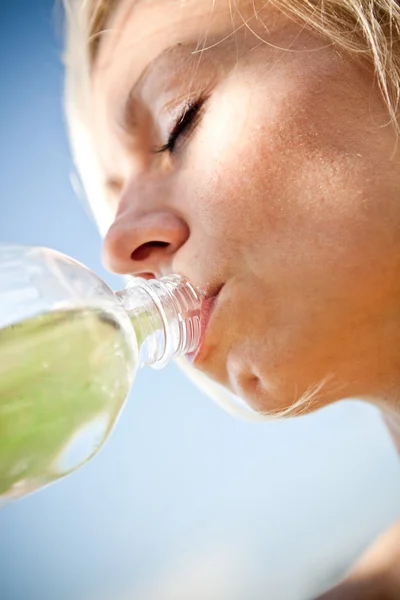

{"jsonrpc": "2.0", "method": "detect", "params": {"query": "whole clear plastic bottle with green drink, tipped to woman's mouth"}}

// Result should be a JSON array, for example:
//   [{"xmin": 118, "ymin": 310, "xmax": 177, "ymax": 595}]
[{"xmin": 0, "ymin": 245, "xmax": 203, "ymax": 504}]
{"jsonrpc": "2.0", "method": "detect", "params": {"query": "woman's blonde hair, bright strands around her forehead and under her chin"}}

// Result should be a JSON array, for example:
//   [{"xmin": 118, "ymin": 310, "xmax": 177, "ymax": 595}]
[{"xmin": 64, "ymin": 0, "xmax": 400, "ymax": 419}]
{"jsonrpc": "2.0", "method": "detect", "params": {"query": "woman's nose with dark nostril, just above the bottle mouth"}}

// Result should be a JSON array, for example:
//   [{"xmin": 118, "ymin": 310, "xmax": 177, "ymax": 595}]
[{"xmin": 103, "ymin": 180, "xmax": 189, "ymax": 278}]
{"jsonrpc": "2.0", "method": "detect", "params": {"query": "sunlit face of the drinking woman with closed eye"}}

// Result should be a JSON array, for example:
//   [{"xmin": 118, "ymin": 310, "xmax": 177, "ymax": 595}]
[{"xmin": 92, "ymin": 0, "xmax": 400, "ymax": 411}]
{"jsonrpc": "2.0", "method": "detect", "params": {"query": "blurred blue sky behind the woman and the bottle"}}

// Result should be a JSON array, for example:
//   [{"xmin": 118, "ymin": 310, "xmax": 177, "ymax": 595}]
[{"xmin": 0, "ymin": 0, "xmax": 400, "ymax": 600}]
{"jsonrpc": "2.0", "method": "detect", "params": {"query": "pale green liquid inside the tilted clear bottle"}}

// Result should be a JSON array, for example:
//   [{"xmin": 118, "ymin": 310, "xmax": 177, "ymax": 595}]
[{"xmin": 0, "ymin": 308, "xmax": 136, "ymax": 504}]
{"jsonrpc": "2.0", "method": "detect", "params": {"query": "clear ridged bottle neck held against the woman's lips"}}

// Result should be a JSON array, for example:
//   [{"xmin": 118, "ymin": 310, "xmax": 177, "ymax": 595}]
[{"xmin": 115, "ymin": 275, "xmax": 201, "ymax": 369}]
